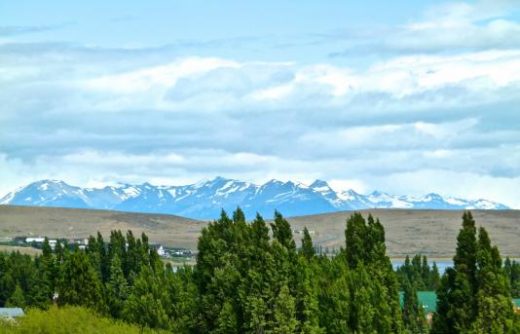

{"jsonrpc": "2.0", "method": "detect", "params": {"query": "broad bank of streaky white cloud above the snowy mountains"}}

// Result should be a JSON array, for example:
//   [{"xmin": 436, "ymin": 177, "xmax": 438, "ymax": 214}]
[{"xmin": 0, "ymin": 1, "xmax": 520, "ymax": 208}]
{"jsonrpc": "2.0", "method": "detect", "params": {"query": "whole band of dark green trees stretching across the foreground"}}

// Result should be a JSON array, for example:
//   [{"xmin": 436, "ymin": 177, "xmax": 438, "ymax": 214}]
[{"xmin": 0, "ymin": 209, "xmax": 520, "ymax": 333}]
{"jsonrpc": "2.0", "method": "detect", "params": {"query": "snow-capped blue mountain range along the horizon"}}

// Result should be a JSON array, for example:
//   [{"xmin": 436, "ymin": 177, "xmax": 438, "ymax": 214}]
[{"xmin": 0, "ymin": 177, "xmax": 508, "ymax": 219}]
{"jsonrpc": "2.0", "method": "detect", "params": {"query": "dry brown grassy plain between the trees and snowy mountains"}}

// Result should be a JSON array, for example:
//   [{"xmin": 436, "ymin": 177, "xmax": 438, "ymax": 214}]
[{"xmin": 0, "ymin": 206, "xmax": 520, "ymax": 259}]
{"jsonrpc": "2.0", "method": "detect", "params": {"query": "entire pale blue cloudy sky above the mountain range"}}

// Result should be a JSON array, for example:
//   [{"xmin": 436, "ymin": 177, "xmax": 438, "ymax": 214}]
[{"xmin": 0, "ymin": 0, "xmax": 520, "ymax": 209}]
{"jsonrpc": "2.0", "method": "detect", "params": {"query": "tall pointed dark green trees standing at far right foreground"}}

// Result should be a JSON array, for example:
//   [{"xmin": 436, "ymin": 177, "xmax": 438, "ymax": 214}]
[{"xmin": 432, "ymin": 212, "xmax": 515, "ymax": 333}]
